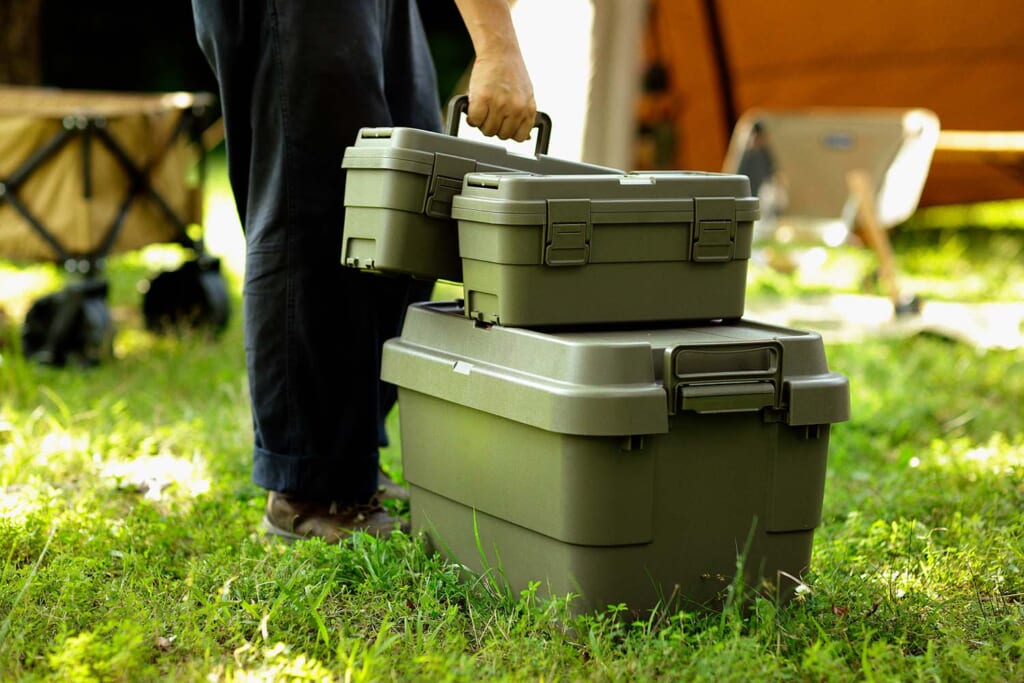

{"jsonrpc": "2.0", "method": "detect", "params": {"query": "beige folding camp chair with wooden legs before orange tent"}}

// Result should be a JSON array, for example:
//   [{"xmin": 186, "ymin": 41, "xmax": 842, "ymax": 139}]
[{"xmin": 724, "ymin": 109, "xmax": 939, "ymax": 314}]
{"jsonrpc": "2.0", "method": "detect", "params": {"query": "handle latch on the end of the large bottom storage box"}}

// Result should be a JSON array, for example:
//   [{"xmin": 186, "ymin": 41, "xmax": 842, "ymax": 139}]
[{"xmin": 663, "ymin": 341, "xmax": 784, "ymax": 421}]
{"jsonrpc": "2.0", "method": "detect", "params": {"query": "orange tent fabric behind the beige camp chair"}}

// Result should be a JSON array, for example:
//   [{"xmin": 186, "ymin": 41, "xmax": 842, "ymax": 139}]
[{"xmin": 640, "ymin": 0, "xmax": 1024, "ymax": 205}]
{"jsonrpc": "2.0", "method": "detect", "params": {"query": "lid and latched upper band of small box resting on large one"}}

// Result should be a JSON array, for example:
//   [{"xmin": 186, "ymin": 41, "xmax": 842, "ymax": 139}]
[{"xmin": 452, "ymin": 171, "xmax": 760, "ymax": 266}]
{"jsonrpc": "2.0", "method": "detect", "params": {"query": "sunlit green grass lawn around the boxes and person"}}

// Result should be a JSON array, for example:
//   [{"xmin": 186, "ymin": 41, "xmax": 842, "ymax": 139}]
[{"xmin": 0, "ymin": 192, "xmax": 1024, "ymax": 681}]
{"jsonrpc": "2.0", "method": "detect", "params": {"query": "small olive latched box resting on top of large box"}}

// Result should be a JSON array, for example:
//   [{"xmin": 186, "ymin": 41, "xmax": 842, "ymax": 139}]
[{"xmin": 452, "ymin": 172, "xmax": 758, "ymax": 327}]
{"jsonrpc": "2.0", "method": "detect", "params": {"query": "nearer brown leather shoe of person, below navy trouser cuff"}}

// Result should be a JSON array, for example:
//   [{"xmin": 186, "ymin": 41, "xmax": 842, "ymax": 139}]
[{"xmin": 263, "ymin": 492, "xmax": 409, "ymax": 544}]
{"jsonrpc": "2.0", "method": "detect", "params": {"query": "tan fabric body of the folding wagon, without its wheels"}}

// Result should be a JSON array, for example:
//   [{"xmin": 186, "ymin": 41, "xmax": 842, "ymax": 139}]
[{"xmin": 0, "ymin": 86, "xmax": 213, "ymax": 261}]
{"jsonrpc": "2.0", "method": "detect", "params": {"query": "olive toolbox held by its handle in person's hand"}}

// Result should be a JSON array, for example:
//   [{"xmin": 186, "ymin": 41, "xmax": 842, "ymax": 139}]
[{"xmin": 341, "ymin": 128, "xmax": 622, "ymax": 282}]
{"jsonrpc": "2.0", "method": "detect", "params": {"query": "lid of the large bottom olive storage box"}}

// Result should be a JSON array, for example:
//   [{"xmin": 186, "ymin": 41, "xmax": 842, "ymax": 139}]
[{"xmin": 381, "ymin": 302, "xmax": 850, "ymax": 435}]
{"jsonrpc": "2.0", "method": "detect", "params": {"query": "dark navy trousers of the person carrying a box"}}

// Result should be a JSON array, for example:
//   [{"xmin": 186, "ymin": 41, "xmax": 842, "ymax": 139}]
[{"xmin": 193, "ymin": 0, "xmax": 440, "ymax": 503}]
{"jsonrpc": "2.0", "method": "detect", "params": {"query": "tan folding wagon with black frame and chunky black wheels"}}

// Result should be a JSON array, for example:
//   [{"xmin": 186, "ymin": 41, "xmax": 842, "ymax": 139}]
[{"xmin": 0, "ymin": 86, "xmax": 227, "ymax": 365}]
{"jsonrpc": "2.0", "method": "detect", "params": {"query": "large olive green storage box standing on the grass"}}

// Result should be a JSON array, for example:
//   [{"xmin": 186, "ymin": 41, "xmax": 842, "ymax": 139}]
[{"xmin": 382, "ymin": 303, "xmax": 849, "ymax": 610}]
